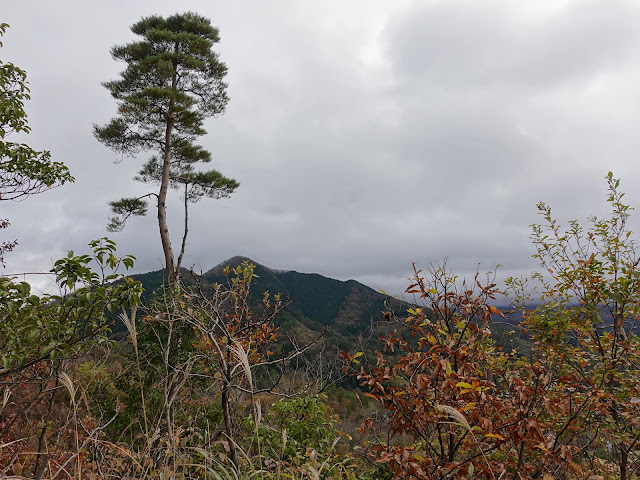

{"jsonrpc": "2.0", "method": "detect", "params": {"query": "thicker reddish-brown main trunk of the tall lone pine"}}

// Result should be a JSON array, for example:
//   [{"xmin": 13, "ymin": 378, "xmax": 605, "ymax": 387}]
[{"xmin": 158, "ymin": 66, "xmax": 179, "ymax": 288}]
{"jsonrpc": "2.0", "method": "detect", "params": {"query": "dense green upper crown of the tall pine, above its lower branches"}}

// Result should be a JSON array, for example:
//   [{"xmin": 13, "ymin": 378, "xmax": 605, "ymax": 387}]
[{"xmin": 95, "ymin": 13, "xmax": 229, "ymax": 157}]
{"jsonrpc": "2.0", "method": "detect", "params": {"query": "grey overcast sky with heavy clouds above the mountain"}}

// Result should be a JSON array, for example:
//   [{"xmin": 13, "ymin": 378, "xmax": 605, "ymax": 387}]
[{"xmin": 0, "ymin": 0, "xmax": 640, "ymax": 293}]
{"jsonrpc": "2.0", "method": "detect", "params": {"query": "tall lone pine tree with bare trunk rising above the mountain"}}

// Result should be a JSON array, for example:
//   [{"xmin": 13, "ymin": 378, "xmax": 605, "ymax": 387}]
[{"xmin": 94, "ymin": 12, "xmax": 238, "ymax": 286}]
